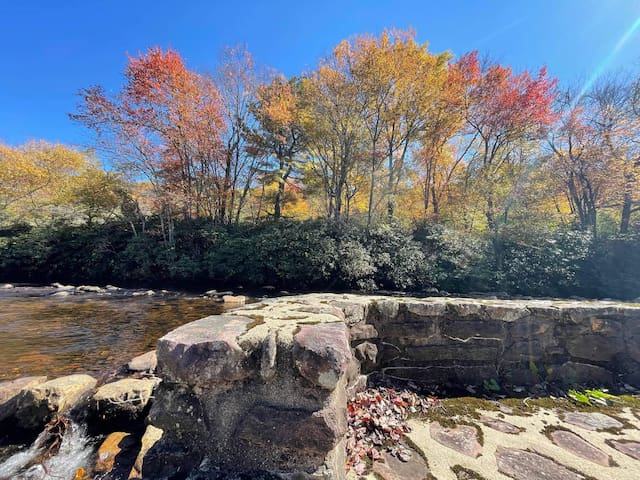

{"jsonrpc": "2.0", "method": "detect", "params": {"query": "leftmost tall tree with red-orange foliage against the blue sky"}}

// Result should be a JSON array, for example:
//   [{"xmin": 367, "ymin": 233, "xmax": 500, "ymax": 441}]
[{"xmin": 71, "ymin": 48, "xmax": 228, "ymax": 241}]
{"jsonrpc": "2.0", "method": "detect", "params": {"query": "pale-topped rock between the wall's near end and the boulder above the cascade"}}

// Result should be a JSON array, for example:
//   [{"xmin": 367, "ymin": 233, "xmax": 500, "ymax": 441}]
[{"xmin": 91, "ymin": 378, "xmax": 160, "ymax": 420}]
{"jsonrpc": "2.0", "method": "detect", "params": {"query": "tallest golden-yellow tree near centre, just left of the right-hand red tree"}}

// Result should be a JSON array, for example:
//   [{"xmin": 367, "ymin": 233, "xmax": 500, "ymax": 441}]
[{"xmin": 334, "ymin": 30, "xmax": 449, "ymax": 224}]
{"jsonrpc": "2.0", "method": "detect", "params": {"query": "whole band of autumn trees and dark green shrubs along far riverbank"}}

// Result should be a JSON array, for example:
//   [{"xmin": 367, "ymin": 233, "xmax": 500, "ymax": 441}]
[{"xmin": 0, "ymin": 30, "xmax": 640, "ymax": 299}]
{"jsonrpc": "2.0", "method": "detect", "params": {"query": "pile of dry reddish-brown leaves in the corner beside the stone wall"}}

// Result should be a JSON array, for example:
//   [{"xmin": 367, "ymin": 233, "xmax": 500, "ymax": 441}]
[{"xmin": 347, "ymin": 387, "xmax": 438, "ymax": 475}]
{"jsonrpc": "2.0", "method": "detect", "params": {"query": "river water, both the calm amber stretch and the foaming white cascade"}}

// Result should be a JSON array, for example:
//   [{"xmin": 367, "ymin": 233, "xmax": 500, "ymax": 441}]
[{"xmin": 0, "ymin": 287, "xmax": 248, "ymax": 480}]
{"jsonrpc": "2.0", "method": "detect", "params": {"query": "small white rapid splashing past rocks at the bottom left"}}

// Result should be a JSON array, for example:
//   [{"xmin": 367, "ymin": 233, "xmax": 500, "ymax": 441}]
[{"xmin": 0, "ymin": 419, "xmax": 95, "ymax": 480}]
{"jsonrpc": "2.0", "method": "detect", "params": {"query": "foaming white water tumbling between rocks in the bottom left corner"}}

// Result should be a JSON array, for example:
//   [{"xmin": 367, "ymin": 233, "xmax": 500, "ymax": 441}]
[{"xmin": 0, "ymin": 423, "xmax": 93, "ymax": 480}]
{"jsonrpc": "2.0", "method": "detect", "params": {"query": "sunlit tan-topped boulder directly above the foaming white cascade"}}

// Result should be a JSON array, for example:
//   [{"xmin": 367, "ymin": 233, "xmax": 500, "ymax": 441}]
[{"xmin": 15, "ymin": 375, "xmax": 96, "ymax": 428}]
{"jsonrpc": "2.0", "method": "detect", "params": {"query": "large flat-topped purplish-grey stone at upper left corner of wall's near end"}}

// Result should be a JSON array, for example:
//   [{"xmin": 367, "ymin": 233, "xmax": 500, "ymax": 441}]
[{"xmin": 157, "ymin": 315, "xmax": 257, "ymax": 388}]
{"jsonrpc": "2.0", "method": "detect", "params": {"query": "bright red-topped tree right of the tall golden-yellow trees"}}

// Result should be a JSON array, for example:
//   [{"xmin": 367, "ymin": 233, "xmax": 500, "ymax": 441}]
[{"xmin": 455, "ymin": 52, "xmax": 556, "ymax": 263}]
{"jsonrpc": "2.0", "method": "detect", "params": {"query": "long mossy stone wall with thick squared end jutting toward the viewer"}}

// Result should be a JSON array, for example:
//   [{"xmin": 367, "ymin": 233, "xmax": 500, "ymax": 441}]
[{"xmin": 144, "ymin": 294, "xmax": 640, "ymax": 479}]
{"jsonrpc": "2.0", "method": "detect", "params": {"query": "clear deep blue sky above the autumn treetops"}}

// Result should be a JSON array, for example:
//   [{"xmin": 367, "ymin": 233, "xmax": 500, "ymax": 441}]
[{"xmin": 0, "ymin": 0, "xmax": 640, "ymax": 144}]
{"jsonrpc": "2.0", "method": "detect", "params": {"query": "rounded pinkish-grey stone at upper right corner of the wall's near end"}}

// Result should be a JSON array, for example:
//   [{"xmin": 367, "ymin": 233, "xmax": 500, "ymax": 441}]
[{"xmin": 293, "ymin": 323, "xmax": 353, "ymax": 390}]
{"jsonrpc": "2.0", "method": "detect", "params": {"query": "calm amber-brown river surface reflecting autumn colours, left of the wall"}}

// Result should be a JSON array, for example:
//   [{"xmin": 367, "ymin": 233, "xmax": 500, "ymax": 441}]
[{"xmin": 0, "ymin": 291, "xmax": 229, "ymax": 381}]
